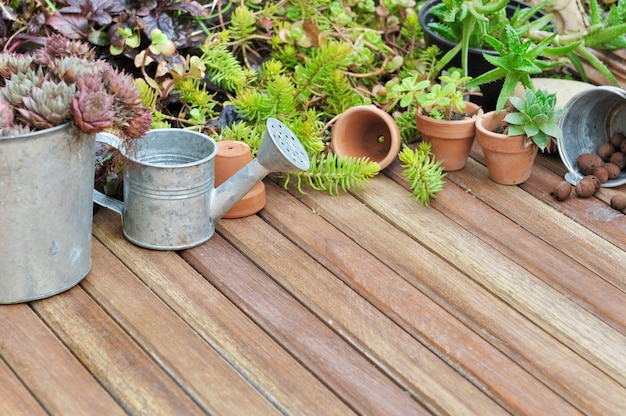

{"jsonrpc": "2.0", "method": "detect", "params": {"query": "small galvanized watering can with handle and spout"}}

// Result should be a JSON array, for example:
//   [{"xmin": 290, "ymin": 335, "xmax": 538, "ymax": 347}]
[{"xmin": 93, "ymin": 118, "xmax": 309, "ymax": 250}]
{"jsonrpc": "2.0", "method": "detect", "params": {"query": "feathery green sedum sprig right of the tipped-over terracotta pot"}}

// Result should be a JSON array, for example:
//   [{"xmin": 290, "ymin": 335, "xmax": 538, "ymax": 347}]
[{"xmin": 398, "ymin": 142, "xmax": 446, "ymax": 206}]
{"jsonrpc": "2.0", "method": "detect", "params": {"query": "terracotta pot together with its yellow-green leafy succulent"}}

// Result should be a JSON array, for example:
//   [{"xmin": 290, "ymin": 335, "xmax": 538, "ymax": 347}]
[{"xmin": 389, "ymin": 70, "xmax": 483, "ymax": 171}]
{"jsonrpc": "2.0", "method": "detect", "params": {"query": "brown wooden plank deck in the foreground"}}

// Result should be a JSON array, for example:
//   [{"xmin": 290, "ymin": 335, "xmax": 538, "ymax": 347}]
[{"xmin": 0, "ymin": 144, "xmax": 626, "ymax": 416}]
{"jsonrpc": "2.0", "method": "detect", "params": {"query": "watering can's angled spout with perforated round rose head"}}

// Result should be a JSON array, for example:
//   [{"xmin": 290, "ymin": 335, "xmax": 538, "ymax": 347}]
[{"xmin": 209, "ymin": 118, "xmax": 309, "ymax": 222}]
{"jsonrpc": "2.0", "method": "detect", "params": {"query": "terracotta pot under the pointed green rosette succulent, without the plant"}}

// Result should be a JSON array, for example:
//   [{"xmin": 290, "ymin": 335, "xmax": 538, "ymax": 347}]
[{"xmin": 476, "ymin": 111, "xmax": 539, "ymax": 185}]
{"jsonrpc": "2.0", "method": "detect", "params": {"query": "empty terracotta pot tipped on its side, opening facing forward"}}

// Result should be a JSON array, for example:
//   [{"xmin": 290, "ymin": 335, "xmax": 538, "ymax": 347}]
[{"xmin": 331, "ymin": 105, "xmax": 401, "ymax": 169}]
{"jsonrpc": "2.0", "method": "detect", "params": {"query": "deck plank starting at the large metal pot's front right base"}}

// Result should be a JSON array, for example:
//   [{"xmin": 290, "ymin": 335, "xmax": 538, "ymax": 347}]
[{"xmin": 32, "ymin": 284, "xmax": 203, "ymax": 415}]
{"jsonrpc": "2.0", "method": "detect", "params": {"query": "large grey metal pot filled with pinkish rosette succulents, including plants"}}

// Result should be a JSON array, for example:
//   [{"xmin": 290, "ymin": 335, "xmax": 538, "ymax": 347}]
[{"xmin": 0, "ymin": 35, "xmax": 152, "ymax": 303}]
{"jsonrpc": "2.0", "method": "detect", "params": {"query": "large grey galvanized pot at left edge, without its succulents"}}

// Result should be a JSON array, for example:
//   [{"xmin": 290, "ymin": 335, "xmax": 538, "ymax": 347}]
[{"xmin": 0, "ymin": 124, "xmax": 95, "ymax": 303}]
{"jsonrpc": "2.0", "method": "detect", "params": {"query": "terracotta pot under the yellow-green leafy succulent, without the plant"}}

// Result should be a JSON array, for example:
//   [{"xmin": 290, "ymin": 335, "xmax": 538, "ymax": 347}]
[{"xmin": 415, "ymin": 102, "xmax": 483, "ymax": 171}]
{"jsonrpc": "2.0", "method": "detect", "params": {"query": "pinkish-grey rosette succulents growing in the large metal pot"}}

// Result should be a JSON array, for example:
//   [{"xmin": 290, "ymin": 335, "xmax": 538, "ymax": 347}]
[{"xmin": 0, "ymin": 35, "xmax": 152, "ymax": 139}]
